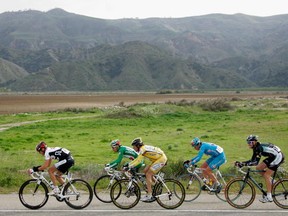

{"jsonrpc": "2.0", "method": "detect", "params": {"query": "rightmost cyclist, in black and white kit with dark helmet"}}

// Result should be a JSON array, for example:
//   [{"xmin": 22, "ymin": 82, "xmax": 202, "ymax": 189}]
[{"xmin": 235, "ymin": 135, "xmax": 284, "ymax": 203}]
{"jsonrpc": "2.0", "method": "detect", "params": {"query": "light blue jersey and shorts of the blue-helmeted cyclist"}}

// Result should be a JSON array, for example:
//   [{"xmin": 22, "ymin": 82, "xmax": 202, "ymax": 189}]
[{"xmin": 191, "ymin": 142, "xmax": 226, "ymax": 170}]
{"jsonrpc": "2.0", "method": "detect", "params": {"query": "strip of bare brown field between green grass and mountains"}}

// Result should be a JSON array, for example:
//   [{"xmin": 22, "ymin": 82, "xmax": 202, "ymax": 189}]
[{"xmin": 0, "ymin": 92, "xmax": 287, "ymax": 115}]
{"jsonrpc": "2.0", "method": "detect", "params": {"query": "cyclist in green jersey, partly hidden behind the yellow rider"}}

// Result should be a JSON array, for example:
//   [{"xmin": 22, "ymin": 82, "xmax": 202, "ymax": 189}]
[{"xmin": 105, "ymin": 139, "xmax": 143, "ymax": 172}]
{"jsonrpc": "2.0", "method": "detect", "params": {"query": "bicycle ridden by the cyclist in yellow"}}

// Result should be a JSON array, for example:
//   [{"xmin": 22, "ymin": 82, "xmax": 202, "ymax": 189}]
[{"xmin": 110, "ymin": 172, "xmax": 185, "ymax": 209}]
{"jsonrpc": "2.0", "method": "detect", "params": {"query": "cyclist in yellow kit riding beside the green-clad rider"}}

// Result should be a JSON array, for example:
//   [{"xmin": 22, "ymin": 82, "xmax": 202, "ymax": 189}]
[{"xmin": 128, "ymin": 137, "xmax": 167, "ymax": 202}]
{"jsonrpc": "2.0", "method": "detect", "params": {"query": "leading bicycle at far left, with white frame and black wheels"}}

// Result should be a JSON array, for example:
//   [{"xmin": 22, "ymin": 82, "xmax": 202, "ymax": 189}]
[{"xmin": 19, "ymin": 171, "xmax": 93, "ymax": 209}]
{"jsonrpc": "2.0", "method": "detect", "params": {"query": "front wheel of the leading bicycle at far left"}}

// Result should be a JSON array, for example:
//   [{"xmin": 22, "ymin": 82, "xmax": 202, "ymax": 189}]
[{"xmin": 19, "ymin": 179, "xmax": 49, "ymax": 209}]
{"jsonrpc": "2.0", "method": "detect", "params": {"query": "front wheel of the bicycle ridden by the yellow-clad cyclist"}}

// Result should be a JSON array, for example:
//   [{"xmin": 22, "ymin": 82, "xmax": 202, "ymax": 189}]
[{"xmin": 110, "ymin": 179, "xmax": 141, "ymax": 209}]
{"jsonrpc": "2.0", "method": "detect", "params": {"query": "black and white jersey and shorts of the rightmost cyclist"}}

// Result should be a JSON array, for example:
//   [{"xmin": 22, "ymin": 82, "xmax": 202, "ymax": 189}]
[{"xmin": 243, "ymin": 142, "xmax": 284, "ymax": 170}]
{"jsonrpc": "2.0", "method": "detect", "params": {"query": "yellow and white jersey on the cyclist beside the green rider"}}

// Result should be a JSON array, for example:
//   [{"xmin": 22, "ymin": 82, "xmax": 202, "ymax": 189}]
[{"xmin": 129, "ymin": 145, "xmax": 167, "ymax": 167}]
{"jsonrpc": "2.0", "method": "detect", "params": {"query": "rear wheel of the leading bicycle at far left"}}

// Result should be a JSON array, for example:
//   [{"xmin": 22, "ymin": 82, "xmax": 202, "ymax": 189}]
[{"xmin": 63, "ymin": 179, "xmax": 93, "ymax": 209}]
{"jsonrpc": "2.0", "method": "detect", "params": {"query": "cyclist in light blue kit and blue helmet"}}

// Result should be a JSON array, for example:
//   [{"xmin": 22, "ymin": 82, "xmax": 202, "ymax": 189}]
[{"xmin": 184, "ymin": 137, "xmax": 226, "ymax": 192}]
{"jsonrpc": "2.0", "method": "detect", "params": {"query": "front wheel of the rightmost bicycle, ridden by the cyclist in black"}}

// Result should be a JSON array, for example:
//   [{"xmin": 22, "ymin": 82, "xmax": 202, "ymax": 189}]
[{"xmin": 225, "ymin": 177, "xmax": 256, "ymax": 209}]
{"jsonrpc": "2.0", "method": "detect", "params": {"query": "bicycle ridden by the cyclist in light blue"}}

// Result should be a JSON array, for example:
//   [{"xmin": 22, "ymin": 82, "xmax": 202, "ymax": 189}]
[{"xmin": 177, "ymin": 165, "xmax": 232, "ymax": 202}]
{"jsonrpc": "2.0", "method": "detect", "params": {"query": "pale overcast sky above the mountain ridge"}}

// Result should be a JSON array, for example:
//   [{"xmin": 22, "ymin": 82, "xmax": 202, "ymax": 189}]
[{"xmin": 0, "ymin": 0, "xmax": 288, "ymax": 19}]
